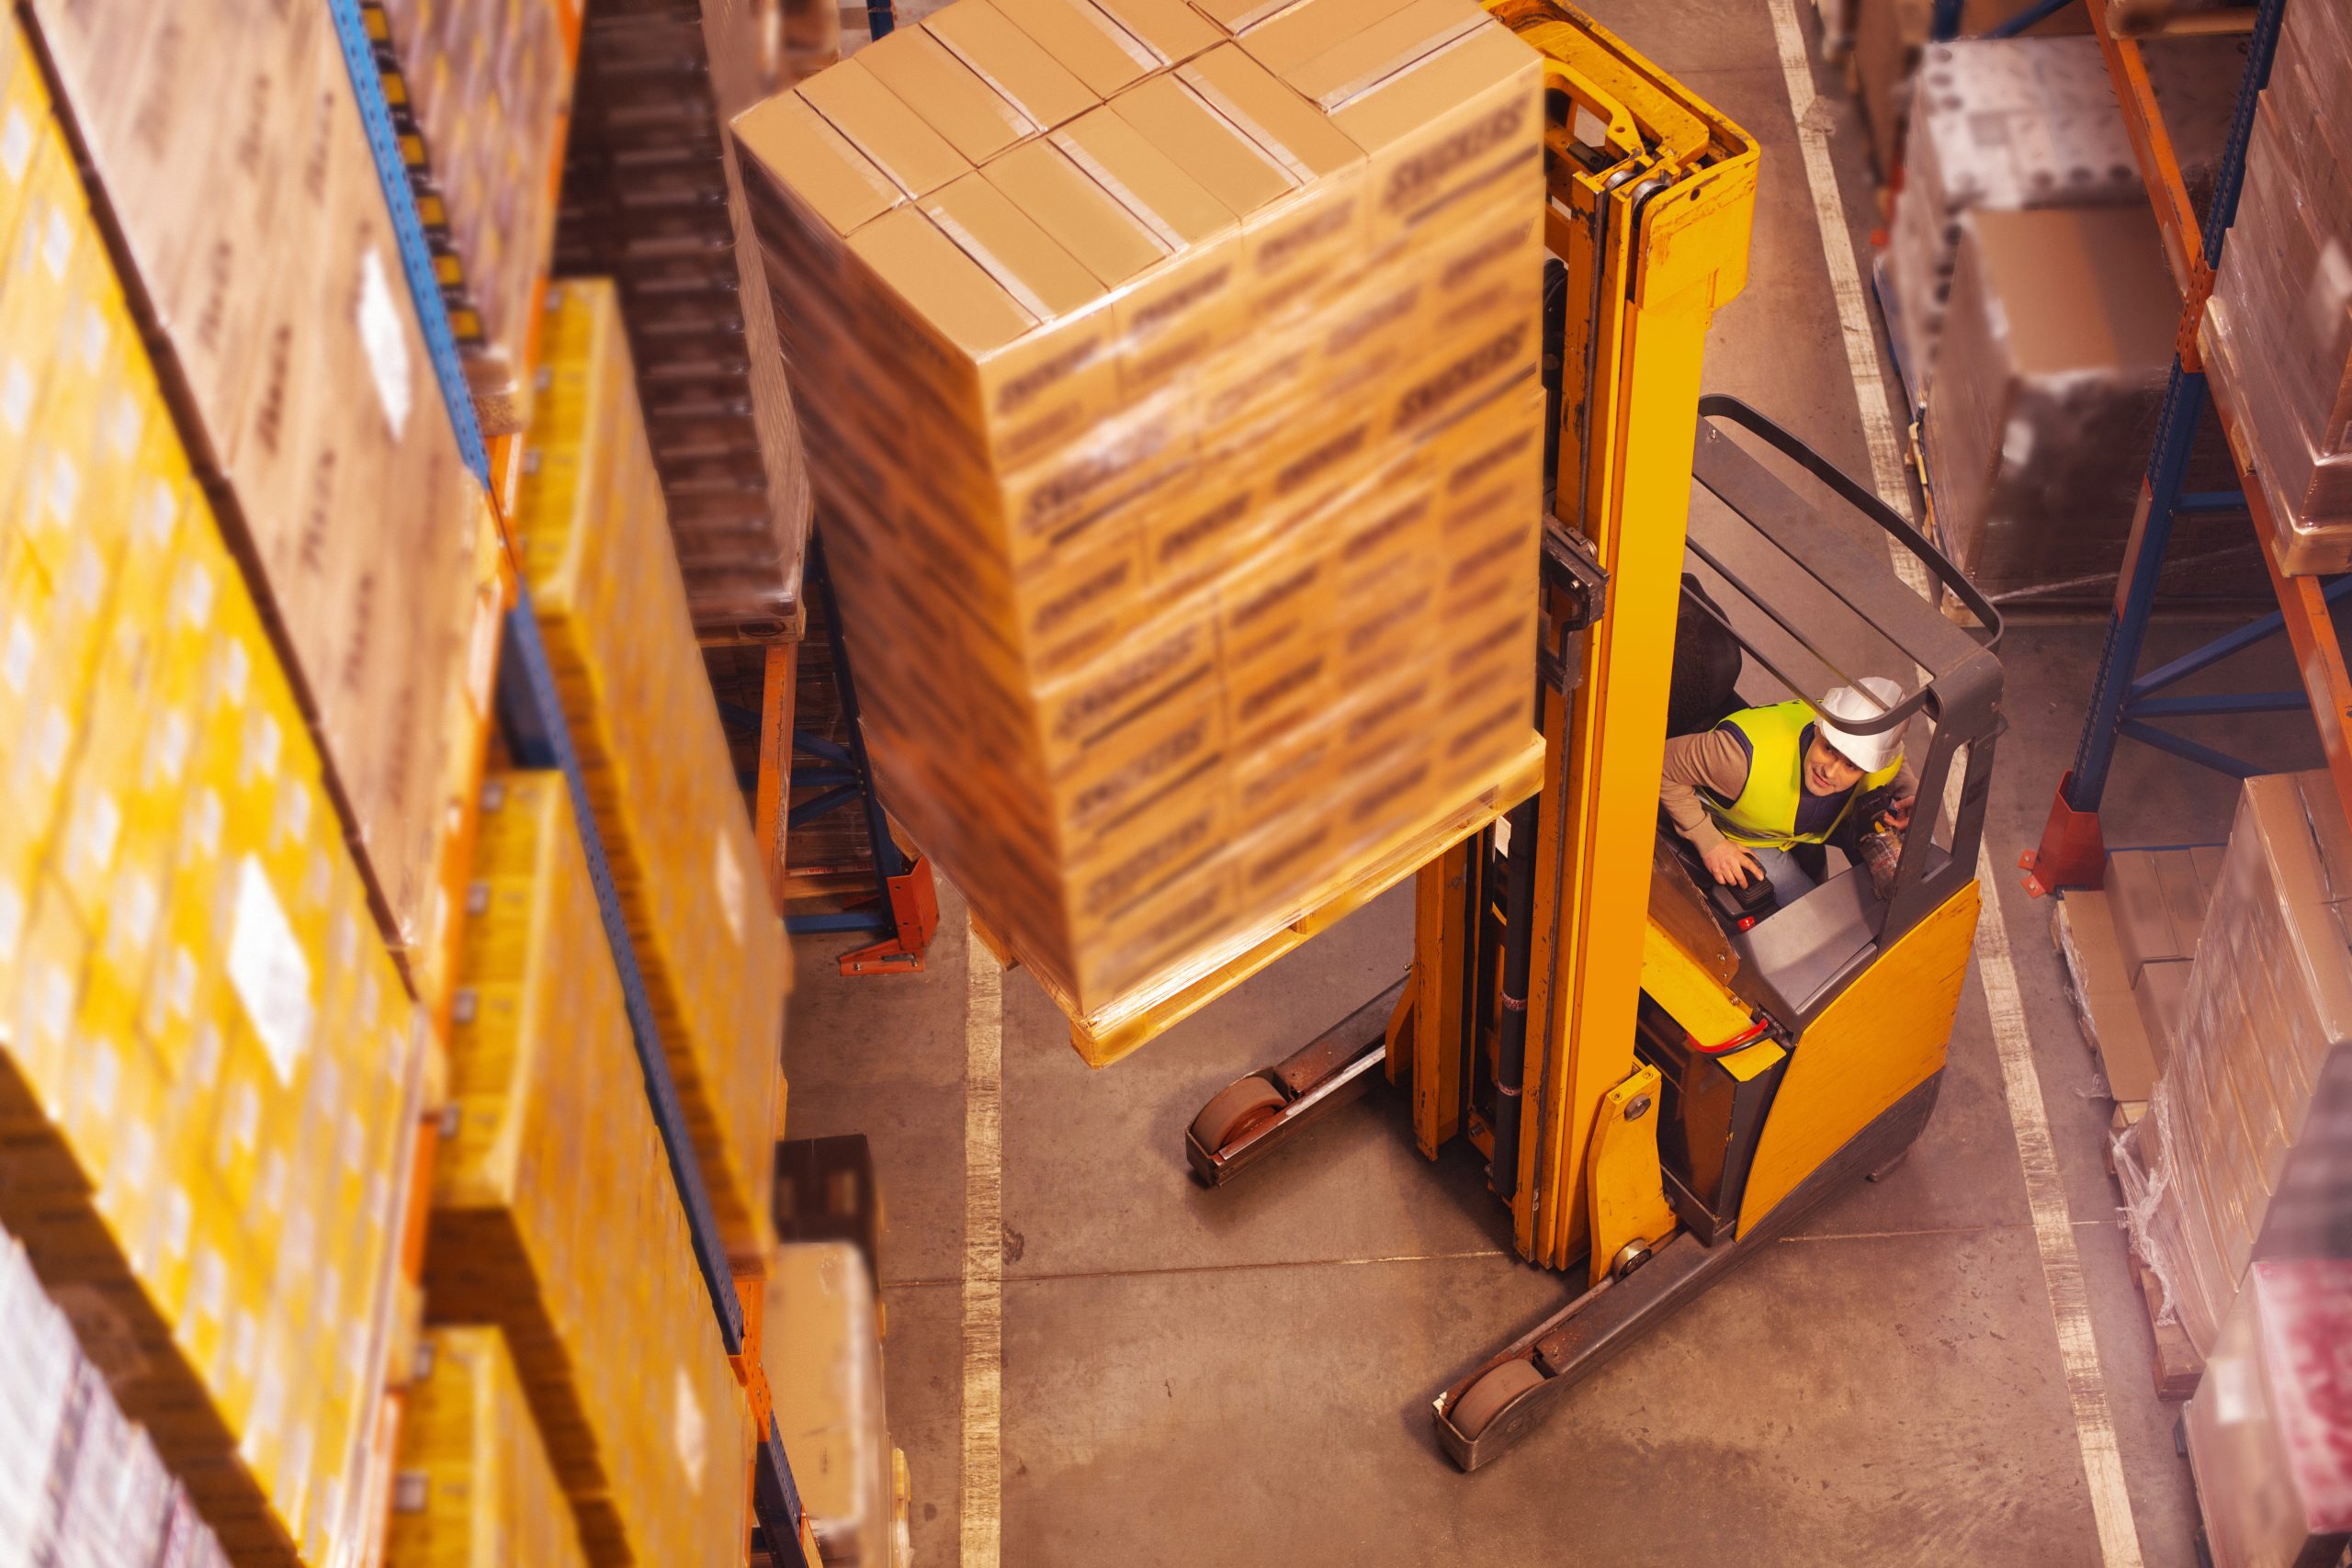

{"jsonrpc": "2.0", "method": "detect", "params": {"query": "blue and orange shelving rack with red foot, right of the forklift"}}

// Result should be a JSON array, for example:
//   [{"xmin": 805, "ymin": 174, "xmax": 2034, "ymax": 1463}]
[{"xmin": 2013, "ymin": 0, "xmax": 2352, "ymax": 896}]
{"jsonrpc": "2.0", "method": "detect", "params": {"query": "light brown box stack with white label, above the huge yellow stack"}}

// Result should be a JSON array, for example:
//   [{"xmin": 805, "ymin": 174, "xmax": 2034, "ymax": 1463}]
[{"xmin": 26, "ymin": 0, "xmax": 496, "ymax": 964}]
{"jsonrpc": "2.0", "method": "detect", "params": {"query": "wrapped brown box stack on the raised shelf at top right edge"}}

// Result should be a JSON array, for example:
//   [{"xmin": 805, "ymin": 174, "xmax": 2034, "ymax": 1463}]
[{"xmin": 2201, "ymin": 5, "xmax": 2352, "ymax": 573}]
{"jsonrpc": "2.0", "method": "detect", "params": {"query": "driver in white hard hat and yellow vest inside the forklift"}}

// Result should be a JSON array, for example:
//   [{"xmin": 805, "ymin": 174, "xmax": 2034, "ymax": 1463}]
[{"xmin": 1658, "ymin": 674, "xmax": 1919, "ymax": 905}]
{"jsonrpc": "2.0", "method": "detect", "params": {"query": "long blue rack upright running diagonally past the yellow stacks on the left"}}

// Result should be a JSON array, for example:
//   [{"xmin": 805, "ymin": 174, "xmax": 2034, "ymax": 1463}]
[{"xmin": 327, "ymin": 0, "xmax": 813, "ymax": 1568}]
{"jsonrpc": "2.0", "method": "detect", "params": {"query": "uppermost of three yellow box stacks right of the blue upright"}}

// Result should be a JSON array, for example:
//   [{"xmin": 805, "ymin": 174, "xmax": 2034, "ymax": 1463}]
[{"xmin": 515, "ymin": 280, "xmax": 786, "ymax": 1258}]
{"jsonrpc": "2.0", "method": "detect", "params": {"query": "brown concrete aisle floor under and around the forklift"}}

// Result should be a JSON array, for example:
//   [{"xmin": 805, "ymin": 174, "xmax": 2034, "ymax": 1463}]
[{"xmin": 788, "ymin": 0, "xmax": 2317, "ymax": 1568}]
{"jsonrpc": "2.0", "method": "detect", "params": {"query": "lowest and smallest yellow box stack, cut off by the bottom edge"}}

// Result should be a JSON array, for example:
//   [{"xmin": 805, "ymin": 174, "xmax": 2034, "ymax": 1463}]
[{"xmin": 386, "ymin": 1328, "xmax": 588, "ymax": 1568}]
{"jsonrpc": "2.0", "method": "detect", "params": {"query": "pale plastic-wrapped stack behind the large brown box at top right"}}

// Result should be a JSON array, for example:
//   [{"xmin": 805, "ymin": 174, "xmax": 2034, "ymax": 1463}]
[{"xmin": 1886, "ymin": 38, "xmax": 2246, "ymax": 398}]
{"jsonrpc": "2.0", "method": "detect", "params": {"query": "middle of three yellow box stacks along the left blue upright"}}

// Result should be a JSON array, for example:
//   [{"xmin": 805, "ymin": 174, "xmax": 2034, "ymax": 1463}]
[{"xmin": 425, "ymin": 773, "xmax": 751, "ymax": 1568}]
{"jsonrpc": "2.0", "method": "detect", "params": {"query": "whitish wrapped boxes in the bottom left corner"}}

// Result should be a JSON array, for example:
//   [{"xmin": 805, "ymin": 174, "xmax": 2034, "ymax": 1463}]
[{"xmin": 0, "ymin": 1232, "xmax": 228, "ymax": 1568}]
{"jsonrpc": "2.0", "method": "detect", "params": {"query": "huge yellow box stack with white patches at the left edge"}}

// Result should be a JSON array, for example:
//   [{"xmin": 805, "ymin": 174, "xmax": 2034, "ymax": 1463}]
[{"xmin": 0, "ymin": 30, "xmax": 425, "ymax": 1563}]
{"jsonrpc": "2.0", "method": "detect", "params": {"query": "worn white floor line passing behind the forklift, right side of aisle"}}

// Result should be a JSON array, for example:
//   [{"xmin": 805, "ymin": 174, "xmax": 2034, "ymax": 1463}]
[{"xmin": 1771, "ymin": 0, "xmax": 2141, "ymax": 1568}]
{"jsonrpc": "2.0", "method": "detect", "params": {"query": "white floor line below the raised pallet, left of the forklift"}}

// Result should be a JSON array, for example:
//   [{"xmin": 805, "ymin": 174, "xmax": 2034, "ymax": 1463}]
[{"xmin": 962, "ymin": 912, "xmax": 1004, "ymax": 1568}]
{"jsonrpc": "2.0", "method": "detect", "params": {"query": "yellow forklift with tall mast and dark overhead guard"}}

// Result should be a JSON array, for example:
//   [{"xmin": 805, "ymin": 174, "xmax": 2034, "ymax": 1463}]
[{"xmin": 1185, "ymin": 0, "xmax": 2002, "ymax": 1470}]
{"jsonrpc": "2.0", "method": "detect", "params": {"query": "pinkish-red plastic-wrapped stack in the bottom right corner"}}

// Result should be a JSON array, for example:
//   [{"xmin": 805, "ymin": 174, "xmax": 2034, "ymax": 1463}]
[{"xmin": 2183, "ymin": 1258, "xmax": 2352, "ymax": 1568}]
